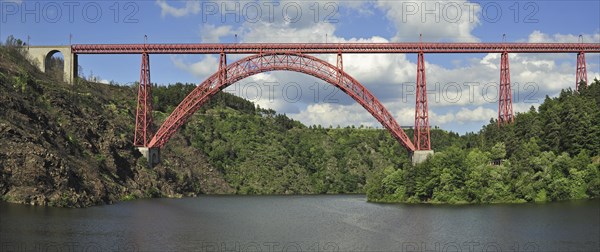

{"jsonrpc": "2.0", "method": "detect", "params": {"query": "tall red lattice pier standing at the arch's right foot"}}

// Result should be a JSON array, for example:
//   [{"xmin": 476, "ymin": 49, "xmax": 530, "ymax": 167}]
[{"xmin": 414, "ymin": 52, "xmax": 431, "ymax": 151}]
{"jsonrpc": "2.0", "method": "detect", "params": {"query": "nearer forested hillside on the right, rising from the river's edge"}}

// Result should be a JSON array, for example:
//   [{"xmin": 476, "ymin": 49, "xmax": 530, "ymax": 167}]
[{"xmin": 367, "ymin": 80, "xmax": 600, "ymax": 203}]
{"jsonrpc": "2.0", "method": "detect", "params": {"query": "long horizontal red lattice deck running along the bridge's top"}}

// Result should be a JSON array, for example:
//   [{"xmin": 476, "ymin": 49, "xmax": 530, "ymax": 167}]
[{"xmin": 72, "ymin": 43, "xmax": 600, "ymax": 54}]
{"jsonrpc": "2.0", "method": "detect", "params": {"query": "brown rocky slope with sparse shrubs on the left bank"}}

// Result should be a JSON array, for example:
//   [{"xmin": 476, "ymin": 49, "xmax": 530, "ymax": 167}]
[{"xmin": 0, "ymin": 48, "xmax": 233, "ymax": 207}]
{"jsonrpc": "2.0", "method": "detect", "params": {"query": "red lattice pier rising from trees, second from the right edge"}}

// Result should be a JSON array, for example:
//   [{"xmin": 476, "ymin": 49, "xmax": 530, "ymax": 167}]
[{"xmin": 498, "ymin": 51, "xmax": 515, "ymax": 126}]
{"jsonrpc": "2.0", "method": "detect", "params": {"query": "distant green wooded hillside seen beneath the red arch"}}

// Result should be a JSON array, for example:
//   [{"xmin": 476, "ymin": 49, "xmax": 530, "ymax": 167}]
[{"xmin": 153, "ymin": 83, "xmax": 460, "ymax": 194}]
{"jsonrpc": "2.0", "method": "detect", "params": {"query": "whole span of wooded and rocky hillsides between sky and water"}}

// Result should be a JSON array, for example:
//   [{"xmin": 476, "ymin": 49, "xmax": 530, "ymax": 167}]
[{"xmin": 0, "ymin": 38, "xmax": 600, "ymax": 207}]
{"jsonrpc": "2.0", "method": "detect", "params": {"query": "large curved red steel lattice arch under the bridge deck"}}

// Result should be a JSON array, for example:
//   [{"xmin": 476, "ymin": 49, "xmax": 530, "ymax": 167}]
[{"xmin": 148, "ymin": 52, "xmax": 415, "ymax": 152}]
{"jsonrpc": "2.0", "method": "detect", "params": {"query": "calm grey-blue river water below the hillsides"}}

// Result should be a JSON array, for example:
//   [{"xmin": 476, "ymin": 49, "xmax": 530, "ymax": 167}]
[{"xmin": 0, "ymin": 195, "xmax": 600, "ymax": 251}]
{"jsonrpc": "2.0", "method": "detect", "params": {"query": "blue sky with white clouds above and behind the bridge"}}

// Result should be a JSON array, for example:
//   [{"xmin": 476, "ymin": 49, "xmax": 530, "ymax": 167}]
[{"xmin": 0, "ymin": 0, "xmax": 600, "ymax": 133}]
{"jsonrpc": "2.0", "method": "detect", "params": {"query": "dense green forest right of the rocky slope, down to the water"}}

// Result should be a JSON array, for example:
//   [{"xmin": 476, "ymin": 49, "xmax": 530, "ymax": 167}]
[{"xmin": 154, "ymin": 80, "xmax": 600, "ymax": 203}]
